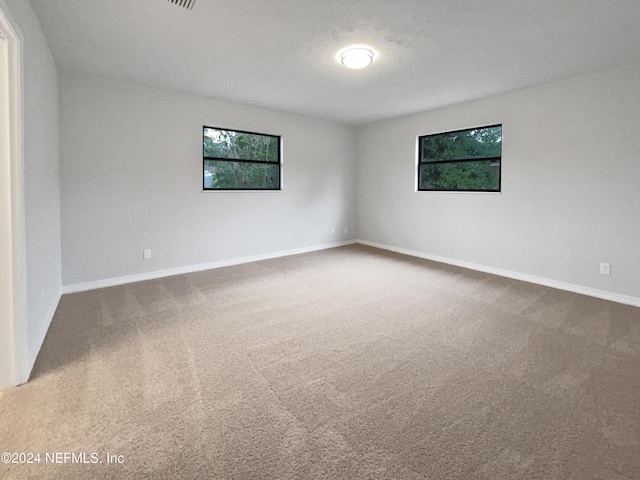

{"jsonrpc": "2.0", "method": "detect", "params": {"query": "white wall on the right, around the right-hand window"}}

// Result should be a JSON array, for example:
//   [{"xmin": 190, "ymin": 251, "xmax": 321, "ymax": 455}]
[{"xmin": 358, "ymin": 65, "xmax": 640, "ymax": 298}]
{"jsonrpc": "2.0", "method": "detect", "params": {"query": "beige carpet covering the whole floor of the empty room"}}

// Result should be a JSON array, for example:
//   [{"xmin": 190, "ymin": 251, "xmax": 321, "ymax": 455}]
[{"xmin": 0, "ymin": 246, "xmax": 640, "ymax": 480}]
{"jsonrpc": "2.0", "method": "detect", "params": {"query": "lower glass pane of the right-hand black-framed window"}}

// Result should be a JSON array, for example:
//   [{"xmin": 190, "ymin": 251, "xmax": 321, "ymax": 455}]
[{"xmin": 420, "ymin": 160, "xmax": 500, "ymax": 192}]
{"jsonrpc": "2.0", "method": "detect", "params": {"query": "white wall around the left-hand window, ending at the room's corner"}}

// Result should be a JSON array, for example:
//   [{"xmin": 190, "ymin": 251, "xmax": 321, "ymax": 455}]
[{"xmin": 60, "ymin": 72, "xmax": 357, "ymax": 287}]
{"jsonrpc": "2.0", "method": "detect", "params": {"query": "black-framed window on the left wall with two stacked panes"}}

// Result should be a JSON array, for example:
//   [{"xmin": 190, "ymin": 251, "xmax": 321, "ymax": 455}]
[{"xmin": 202, "ymin": 127, "xmax": 281, "ymax": 190}]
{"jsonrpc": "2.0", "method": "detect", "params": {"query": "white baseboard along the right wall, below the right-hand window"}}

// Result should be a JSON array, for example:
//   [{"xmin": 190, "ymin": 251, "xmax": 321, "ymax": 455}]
[{"xmin": 357, "ymin": 240, "xmax": 640, "ymax": 307}]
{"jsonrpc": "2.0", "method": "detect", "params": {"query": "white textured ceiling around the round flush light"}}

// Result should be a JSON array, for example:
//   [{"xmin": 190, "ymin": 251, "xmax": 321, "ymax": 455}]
[{"xmin": 31, "ymin": 0, "xmax": 640, "ymax": 124}]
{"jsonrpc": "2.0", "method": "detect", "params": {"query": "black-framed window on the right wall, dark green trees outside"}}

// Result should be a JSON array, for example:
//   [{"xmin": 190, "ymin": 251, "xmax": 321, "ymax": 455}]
[{"xmin": 418, "ymin": 125, "xmax": 502, "ymax": 192}]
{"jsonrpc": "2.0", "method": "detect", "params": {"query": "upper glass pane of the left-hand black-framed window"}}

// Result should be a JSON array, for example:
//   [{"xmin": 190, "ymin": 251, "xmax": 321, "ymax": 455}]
[{"xmin": 202, "ymin": 127, "xmax": 279, "ymax": 162}]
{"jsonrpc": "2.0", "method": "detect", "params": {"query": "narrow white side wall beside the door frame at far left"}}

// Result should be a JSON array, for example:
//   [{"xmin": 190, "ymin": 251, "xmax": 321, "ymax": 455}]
[{"xmin": 0, "ymin": 0, "xmax": 61, "ymax": 382}]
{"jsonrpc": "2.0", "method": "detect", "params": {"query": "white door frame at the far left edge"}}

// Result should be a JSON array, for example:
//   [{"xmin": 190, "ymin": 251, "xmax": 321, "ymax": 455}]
[{"xmin": 0, "ymin": 6, "xmax": 29, "ymax": 391}]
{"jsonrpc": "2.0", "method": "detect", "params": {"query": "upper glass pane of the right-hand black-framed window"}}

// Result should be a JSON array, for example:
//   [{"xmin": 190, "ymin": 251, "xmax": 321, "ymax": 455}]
[{"xmin": 420, "ymin": 125, "xmax": 502, "ymax": 162}]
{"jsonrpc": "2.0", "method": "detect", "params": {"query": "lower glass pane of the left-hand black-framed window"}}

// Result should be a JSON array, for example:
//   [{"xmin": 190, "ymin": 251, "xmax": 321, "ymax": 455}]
[{"xmin": 204, "ymin": 160, "xmax": 280, "ymax": 190}]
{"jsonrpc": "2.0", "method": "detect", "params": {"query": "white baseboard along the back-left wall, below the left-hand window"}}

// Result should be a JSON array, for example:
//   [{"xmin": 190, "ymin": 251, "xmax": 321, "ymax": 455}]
[{"xmin": 62, "ymin": 240, "xmax": 356, "ymax": 294}]
